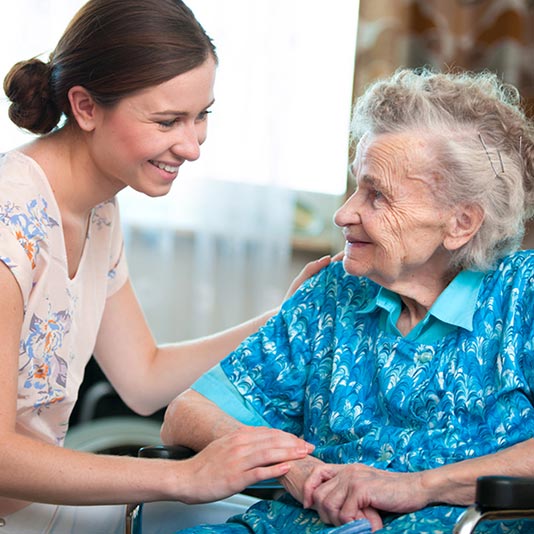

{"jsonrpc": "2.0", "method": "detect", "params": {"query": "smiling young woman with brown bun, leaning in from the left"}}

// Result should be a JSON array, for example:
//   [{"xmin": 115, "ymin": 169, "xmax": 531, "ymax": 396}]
[{"xmin": 0, "ymin": 0, "xmax": 329, "ymax": 533}]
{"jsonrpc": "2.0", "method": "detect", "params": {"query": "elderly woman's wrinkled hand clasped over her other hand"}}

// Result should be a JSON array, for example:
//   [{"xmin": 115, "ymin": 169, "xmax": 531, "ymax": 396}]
[{"xmin": 303, "ymin": 464, "xmax": 428, "ymax": 532}]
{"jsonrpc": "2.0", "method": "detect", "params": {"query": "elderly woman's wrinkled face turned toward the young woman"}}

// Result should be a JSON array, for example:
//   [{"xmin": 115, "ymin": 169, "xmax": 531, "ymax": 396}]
[{"xmin": 334, "ymin": 133, "xmax": 456, "ymax": 289}]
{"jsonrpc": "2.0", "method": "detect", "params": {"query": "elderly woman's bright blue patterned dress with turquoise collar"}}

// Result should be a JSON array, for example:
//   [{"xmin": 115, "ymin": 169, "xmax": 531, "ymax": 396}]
[{"xmin": 186, "ymin": 251, "xmax": 534, "ymax": 533}]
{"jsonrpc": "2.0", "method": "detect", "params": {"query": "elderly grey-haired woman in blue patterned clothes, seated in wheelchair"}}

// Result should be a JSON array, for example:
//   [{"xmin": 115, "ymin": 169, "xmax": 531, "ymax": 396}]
[{"xmin": 162, "ymin": 70, "xmax": 534, "ymax": 534}]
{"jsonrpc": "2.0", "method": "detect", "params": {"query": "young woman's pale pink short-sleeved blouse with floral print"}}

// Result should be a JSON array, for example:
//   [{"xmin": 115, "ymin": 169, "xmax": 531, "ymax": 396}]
[{"xmin": 0, "ymin": 151, "xmax": 128, "ymax": 445}]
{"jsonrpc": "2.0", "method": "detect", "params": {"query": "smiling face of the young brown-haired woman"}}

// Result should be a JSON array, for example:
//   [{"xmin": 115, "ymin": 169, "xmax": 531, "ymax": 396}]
[{"xmin": 88, "ymin": 57, "xmax": 216, "ymax": 197}]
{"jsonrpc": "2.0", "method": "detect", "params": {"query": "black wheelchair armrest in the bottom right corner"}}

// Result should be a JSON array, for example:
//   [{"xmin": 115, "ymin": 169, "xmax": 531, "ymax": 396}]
[{"xmin": 475, "ymin": 476, "xmax": 534, "ymax": 510}]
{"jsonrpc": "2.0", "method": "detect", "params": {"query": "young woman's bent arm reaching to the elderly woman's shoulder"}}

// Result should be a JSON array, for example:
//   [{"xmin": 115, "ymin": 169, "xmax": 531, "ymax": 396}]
[{"xmin": 95, "ymin": 256, "xmax": 331, "ymax": 415}]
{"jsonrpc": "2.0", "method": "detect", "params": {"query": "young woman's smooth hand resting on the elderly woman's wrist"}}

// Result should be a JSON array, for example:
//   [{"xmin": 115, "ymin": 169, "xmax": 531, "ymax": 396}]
[{"xmin": 179, "ymin": 427, "xmax": 313, "ymax": 504}]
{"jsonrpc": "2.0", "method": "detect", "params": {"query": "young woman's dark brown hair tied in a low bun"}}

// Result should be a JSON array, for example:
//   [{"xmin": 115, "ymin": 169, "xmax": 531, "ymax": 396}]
[{"xmin": 4, "ymin": 0, "xmax": 217, "ymax": 134}]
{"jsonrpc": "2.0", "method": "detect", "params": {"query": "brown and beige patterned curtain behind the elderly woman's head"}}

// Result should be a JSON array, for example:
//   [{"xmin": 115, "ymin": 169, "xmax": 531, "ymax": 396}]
[{"xmin": 354, "ymin": 0, "xmax": 534, "ymax": 112}]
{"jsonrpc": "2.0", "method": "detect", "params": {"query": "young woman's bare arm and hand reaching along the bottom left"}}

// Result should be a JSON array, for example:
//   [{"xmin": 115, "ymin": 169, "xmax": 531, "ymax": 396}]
[{"xmin": 0, "ymin": 262, "xmax": 314, "ymax": 513}]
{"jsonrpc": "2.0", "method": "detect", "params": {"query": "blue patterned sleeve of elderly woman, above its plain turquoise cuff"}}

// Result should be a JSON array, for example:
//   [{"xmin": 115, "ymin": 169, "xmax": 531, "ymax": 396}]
[{"xmin": 221, "ymin": 273, "xmax": 336, "ymax": 435}]
